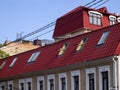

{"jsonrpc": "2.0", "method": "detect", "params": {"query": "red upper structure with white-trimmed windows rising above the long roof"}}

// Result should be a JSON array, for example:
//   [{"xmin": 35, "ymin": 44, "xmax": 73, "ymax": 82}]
[{"xmin": 53, "ymin": 6, "xmax": 120, "ymax": 41}]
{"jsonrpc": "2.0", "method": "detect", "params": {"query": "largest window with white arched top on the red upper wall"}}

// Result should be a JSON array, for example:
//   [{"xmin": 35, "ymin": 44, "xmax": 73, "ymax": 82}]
[{"xmin": 88, "ymin": 11, "xmax": 103, "ymax": 26}]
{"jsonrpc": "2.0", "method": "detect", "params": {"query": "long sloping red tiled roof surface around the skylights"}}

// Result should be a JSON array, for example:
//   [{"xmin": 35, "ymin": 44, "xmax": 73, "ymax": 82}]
[{"xmin": 0, "ymin": 24, "xmax": 120, "ymax": 79}]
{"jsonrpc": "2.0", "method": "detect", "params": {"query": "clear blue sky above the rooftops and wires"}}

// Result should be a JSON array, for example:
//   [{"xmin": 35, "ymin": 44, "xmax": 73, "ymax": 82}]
[{"xmin": 0, "ymin": 0, "xmax": 120, "ymax": 43}]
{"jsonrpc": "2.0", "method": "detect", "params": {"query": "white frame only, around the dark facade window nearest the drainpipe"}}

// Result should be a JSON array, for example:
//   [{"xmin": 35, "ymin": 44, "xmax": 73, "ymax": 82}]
[{"xmin": 98, "ymin": 65, "xmax": 110, "ymax": 90}]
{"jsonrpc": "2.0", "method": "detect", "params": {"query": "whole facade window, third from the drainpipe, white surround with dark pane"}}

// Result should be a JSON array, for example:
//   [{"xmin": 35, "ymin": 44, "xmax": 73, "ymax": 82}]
[{"xmin": 71, "ymin": 70, "xmax": 80, "ymax": 90}]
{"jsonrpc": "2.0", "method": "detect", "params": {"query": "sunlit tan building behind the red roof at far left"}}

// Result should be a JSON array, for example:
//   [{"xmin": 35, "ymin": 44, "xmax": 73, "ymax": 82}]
[{"xmin": 0, "ymin": 39, "xmax": 41, "ymax": 56}]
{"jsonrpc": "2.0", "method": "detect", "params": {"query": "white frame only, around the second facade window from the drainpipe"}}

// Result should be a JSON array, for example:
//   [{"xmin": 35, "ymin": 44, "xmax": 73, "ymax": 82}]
[{"xmin": 85, "ymin": 68, "xmax": 96, "ymax": 90}]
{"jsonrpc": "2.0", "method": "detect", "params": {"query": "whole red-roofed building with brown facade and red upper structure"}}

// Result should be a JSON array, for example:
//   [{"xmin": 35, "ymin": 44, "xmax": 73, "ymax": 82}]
[{"xmin": 0, "ymin": 7, "xmax": 120, "ymax": 90}]
